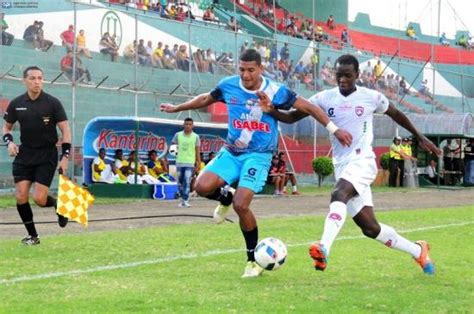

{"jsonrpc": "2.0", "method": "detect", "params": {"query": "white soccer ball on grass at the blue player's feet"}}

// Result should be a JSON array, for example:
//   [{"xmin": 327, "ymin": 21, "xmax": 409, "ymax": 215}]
[{"xmin": 255, "ymin": 238, "xmax": 287, "ymax": 270}]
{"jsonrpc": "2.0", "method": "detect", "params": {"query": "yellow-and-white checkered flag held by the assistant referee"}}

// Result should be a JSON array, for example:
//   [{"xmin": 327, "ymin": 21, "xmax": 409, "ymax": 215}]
[{"xmin": 56, "ymin": 174, "xmax": 94, "ymax": 227}]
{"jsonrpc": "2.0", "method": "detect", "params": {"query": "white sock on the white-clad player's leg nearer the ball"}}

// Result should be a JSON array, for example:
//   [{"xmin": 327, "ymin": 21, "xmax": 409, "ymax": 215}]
[{"xmin": 320, "ymin": 202, "xmax": 347, "ymax": 255}]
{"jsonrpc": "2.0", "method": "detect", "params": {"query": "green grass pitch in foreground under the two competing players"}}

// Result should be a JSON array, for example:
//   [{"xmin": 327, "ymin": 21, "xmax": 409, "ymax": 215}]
[{"xmin": 0, "ymin": 206, "xmax": 474, "ymax": 313}]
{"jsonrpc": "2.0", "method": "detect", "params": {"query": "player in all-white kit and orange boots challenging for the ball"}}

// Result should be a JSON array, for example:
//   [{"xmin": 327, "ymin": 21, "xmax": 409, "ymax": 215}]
[{"xmin": 262, "ymin": 55, "xmax": 441, "ymax": 274}]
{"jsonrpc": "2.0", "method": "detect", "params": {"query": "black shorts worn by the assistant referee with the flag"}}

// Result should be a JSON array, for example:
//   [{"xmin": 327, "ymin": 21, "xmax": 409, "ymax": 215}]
[{"xmin": 12, "ymin": 145, "xmax": 58, "ymax": 187}]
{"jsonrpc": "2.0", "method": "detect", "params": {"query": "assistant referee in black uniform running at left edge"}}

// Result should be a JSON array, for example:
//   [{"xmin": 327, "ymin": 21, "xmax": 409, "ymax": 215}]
[{"xmin": 3, "ymin": 66, "xmax": 71, "ymax": 245}]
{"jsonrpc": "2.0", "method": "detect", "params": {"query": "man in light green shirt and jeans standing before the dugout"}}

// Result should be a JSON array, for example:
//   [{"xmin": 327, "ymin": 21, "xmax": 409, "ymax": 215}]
[{"xmin": 171, "ymin": 118, "xmax": 201, "ymax": 207}]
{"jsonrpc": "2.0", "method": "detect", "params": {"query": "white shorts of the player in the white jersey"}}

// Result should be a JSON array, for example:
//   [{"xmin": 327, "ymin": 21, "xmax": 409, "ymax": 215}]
[{"xmin": 335, "ymin": 157, "xmax": 377, "ymax": 217}]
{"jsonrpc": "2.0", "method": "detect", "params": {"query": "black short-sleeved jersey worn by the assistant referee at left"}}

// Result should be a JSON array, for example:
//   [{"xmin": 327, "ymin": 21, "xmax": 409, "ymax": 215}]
[{"xmin": 3, "ymin": 91, "xmax": 67, "ymax": 148}]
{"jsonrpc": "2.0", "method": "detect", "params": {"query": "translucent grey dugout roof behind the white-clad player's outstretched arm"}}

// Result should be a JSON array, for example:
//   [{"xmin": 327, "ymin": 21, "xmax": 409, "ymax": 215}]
[{"xmin": 374, "ymin": 113, "xmax": 474, "ymax": 138}]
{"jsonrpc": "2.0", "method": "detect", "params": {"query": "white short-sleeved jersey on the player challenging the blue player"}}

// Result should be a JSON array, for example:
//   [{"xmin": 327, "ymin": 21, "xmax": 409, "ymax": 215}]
[{"xmin": 309, "ymin": 86, "xmax": 389, "ymax": 165}]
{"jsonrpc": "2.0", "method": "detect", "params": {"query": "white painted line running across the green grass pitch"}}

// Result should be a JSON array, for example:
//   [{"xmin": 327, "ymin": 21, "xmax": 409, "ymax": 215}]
[{"xmin": 0, "ymin": 221, "xmax": 474, "ymax": 285}]
